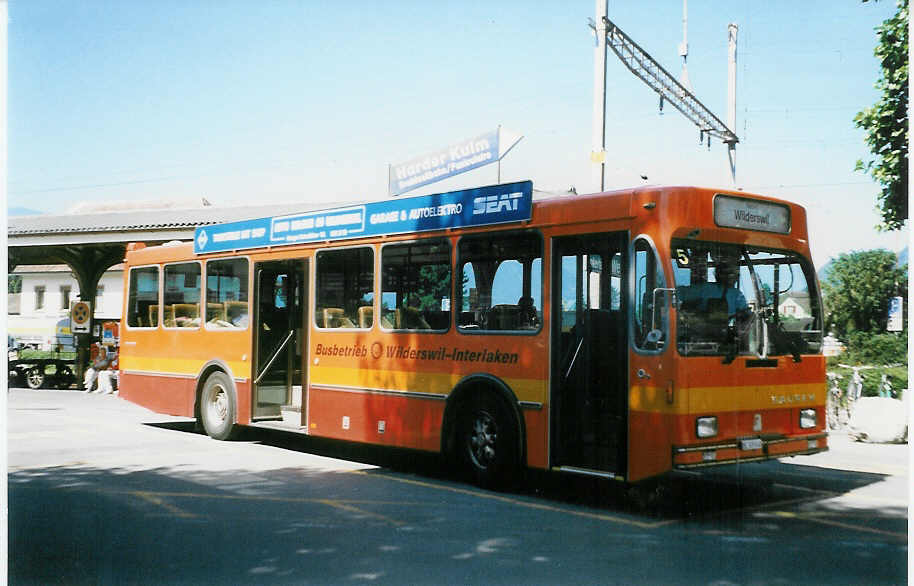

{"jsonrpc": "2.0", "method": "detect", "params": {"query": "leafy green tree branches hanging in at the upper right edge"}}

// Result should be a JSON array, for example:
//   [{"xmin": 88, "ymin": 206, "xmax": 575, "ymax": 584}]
[{"xmin": 854, "ymin": 0, "xmax": 908, "ymax": 230}]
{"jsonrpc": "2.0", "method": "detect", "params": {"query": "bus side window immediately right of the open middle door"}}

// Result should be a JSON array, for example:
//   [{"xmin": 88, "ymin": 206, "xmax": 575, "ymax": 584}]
[{"xmin": 314, "ymin": 246, "xmax": 374, "ymax": 329}]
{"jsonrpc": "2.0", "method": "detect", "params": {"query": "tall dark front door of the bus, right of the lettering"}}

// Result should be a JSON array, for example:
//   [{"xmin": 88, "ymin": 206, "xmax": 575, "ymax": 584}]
[{"xmin": 551, "ymin": 232, "xmax": 628, "ymax": 476}]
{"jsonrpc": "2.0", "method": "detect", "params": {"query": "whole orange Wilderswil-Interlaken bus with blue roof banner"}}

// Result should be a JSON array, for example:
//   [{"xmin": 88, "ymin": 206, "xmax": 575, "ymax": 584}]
[{"xmin": 120, "ymin": 181, "xmax": 828, "ymax": 486}]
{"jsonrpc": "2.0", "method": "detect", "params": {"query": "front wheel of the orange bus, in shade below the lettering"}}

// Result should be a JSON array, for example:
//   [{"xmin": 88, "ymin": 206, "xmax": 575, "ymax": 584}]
[{"xmin": 457, "ymin": 393, "xmax": 520, "ymax": 489}]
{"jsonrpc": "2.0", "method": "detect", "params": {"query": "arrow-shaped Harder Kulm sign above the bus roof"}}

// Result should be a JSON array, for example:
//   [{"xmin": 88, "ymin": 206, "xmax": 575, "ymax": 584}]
[{"xmin": 388, "ymin": 126, "xmax": 523, "ymax": 195}]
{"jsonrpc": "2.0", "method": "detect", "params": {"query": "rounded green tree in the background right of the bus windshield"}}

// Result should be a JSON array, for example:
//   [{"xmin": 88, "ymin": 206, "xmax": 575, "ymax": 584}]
[{"xmin": 822, "ymin": 250, "xmax": 907, "ymax": 336}]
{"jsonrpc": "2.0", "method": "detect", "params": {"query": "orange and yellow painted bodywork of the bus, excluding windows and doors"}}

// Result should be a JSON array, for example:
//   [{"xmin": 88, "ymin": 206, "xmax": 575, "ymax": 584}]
[{"xmin": 120, "ymin": 187, "xmax": 827, "ymax": 481}]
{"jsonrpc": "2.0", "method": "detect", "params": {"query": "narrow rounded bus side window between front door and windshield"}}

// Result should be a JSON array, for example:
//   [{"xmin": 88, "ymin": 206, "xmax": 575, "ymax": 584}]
[{"xmin": 632, "ymin": 238, "xmax": 669, "ymax": 351}]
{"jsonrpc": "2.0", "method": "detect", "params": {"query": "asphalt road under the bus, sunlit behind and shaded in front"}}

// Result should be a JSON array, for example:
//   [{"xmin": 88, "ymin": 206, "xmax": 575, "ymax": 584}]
[{"xmin": 7, "ymin": 389, "xmax": 908, "ymax": 585}]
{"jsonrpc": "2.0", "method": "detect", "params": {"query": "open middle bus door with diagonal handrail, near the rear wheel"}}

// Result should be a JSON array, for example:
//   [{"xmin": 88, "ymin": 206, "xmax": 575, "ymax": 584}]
[{"xmin": 251, "ymin": 259, "xmax": 308, "ymax": 419}]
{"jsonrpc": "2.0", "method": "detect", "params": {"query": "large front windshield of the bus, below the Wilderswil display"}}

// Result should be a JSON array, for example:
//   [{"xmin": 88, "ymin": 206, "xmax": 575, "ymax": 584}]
[{"xmin": 671, "ymin": 240, "xmax": 822, "ymax": 362}]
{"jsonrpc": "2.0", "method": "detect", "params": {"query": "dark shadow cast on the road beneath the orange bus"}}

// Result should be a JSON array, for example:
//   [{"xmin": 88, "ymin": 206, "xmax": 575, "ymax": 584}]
[{"xmin": 146, "ymin": 421, "xmax": 892, "ymax": 521}]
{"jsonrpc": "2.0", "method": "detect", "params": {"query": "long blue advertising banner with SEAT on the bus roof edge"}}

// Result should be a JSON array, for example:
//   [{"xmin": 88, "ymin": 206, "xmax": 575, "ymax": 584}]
[{"xmin": 194, "ymin": 181, "xmax": 533, "ymax": 254}]
